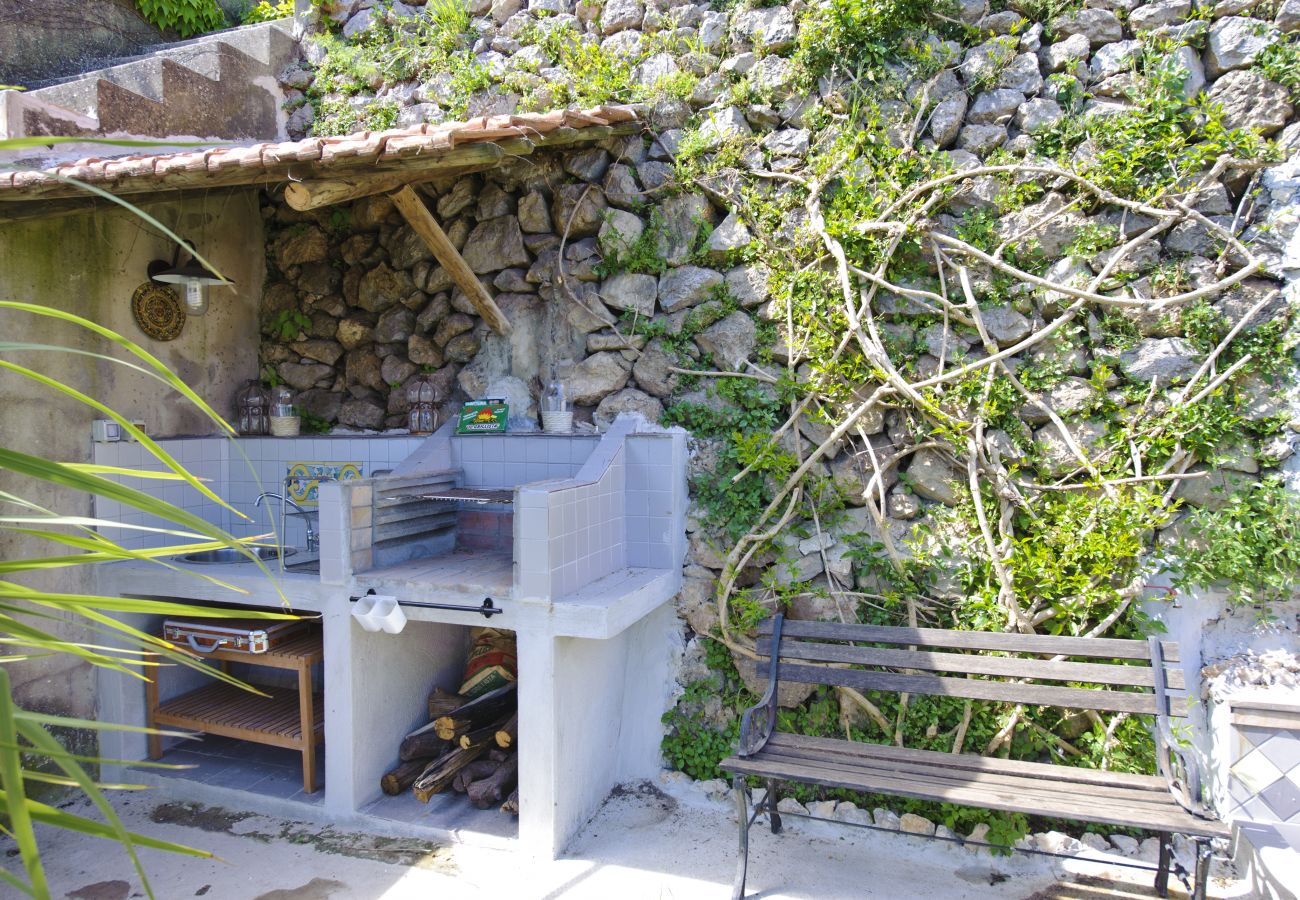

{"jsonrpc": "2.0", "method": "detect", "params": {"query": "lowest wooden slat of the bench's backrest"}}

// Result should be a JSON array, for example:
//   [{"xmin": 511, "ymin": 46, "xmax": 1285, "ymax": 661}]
[{"xmin": 758, "ymin": 658, "xmax": 1187, "ymax": 717}]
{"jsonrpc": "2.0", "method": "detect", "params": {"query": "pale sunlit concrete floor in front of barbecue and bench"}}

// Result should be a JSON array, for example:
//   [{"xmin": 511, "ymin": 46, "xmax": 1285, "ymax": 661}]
[{"xmin": 0, "ymin": 776, "xmax": 1248, "ymax": 900}]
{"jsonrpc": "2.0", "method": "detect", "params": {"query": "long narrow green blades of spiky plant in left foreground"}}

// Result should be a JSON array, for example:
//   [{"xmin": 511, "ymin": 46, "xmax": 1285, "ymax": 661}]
[{"xmin": 0, "ymin": 300, "xmax": 293, "ymax": 897}]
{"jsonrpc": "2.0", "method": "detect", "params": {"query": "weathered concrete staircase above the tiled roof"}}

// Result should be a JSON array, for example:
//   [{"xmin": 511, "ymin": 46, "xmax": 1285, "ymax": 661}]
[{"xmin": 0, "ymin": 20, "xmax": 300, "ymax": 160}]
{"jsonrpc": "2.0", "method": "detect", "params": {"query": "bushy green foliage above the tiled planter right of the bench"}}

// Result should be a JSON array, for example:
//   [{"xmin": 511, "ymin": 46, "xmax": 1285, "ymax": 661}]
[{"xmin": 1170, "ymin": 477, "xmax": 1300, "ymax": 603}]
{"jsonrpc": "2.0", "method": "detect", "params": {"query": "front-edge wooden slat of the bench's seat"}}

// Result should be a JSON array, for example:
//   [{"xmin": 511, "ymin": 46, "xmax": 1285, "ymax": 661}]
[{"xmin": 722, "ymin": 754, "xmax": 1229, "ymax": 836}]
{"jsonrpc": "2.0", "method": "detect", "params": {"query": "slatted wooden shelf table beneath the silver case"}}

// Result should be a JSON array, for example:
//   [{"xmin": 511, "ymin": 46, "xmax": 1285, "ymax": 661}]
[{"xmin": 144, "ymin": 629, "xmax": 325, "ymax": 793}]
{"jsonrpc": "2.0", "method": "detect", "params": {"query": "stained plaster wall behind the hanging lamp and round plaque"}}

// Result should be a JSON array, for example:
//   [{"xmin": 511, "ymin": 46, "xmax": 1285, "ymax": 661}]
[{"xmin": 0, "ymin": 191, "xmax": 265, "ymax": 715}]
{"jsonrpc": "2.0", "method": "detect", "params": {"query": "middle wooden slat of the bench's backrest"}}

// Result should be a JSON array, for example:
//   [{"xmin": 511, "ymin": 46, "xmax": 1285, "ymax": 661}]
[{"xmin": 755, "ymin": 637, "xmax": 1184, "ymax": 689}]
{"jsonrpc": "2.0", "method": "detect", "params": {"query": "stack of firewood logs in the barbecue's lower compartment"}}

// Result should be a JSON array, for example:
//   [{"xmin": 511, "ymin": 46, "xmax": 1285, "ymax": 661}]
[{"xmin": 380, "ymin": 683, "xmax": 519, "ymax": 815}]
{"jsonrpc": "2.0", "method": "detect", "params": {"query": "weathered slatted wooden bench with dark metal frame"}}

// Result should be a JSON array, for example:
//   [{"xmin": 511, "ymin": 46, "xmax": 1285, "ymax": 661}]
[{"xmin": 722, "ymin": 615, "xmax": 1229, "ymax": 900}]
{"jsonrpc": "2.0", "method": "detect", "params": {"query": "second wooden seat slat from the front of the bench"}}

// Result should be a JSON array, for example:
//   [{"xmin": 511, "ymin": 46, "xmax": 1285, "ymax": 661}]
[{"xmin": 759, "ymin": 744, "xmax": 1170, "ymax": 809}]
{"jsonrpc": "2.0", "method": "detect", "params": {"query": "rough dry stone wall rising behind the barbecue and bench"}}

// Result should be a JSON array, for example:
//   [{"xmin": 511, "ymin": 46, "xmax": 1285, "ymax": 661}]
[{"xmin": 263, "ymin": 0, "xmax": 1300, "ymax": 795}]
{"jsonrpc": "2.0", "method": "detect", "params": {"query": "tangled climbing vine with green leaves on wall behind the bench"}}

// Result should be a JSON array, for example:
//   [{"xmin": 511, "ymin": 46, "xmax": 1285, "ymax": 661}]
[{"xmin": 297, "ymin": 0, "xmax": 1300, "ymax": 834}]
